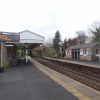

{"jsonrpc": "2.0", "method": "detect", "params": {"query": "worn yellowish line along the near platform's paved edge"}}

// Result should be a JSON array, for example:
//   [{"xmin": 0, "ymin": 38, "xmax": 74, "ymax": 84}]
[{"xmin": 32, "ymin": 60, "xmax": 92, "ymax": 100}]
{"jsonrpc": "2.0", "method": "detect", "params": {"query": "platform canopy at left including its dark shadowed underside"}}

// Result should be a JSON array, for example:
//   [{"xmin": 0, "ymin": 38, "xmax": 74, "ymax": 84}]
[{"xmin": 0, "ymin": 30, "xmax": 45, "ymax": 48}]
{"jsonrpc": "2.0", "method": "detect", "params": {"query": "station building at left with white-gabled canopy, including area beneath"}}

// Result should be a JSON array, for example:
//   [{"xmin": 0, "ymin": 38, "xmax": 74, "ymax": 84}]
[{"xmin": 0, "ymin": 30, "xmax": 45, "ymax": 67}]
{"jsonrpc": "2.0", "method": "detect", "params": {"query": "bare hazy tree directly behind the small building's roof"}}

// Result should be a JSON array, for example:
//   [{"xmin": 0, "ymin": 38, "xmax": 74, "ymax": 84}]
[{"xmin": 76, "ymin": 31, "xmax": 87, "ymax": 44}]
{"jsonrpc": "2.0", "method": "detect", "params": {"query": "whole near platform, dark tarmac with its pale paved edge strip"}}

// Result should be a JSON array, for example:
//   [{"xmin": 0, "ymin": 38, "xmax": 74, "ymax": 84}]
[{"xmin": 0, "ymin": 58, "xmax": 100, "ymax": 100}]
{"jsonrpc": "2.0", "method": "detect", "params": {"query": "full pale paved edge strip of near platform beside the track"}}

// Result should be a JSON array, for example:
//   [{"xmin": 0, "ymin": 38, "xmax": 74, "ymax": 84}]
[{"xmin": 31, "ymin": 59, "xmax": 100, "ymax": 100}]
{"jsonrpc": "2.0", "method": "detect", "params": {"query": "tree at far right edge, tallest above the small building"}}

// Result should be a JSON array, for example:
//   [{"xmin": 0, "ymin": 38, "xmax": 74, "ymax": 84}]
[{"xmin": 89, "ymin": 22, "xmax": 100, "ymax": 42}]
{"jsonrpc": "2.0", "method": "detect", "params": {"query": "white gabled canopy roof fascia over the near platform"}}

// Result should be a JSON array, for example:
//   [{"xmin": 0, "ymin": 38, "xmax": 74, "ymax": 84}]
[{"xmin": 0, "ymin": 30, "xmax": 45, "ymax": 44}]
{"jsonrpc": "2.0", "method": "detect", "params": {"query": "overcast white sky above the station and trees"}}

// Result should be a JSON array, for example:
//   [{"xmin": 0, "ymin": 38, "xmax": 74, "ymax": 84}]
[{"xmin": 0, "ymin": 0, "xmax": 100, "ymax": 39}]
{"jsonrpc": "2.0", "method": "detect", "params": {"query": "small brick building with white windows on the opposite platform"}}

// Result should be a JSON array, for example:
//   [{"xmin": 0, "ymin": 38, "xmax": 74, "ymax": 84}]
[{"xmin": 66, "ymin": 42, "xmax": 100, "ymax": 61}]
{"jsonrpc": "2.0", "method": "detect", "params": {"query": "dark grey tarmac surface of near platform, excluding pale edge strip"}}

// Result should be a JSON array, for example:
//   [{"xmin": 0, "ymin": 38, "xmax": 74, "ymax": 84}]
[{"xmin": 0, "ymin": 65, "xmax": 78, "ymax": 100}]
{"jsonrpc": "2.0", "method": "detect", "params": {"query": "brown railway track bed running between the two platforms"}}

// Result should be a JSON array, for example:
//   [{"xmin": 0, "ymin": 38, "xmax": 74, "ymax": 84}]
[{"xmin": 36, "ymin": 58, "xmax": 100, "ymax": 91}]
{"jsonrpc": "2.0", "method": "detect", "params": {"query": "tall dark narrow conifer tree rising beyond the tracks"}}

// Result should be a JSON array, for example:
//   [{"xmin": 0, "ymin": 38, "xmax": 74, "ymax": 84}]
[{"xmin": 53, "ymin": 31, "xmax": 61, "ymax": 52}]
